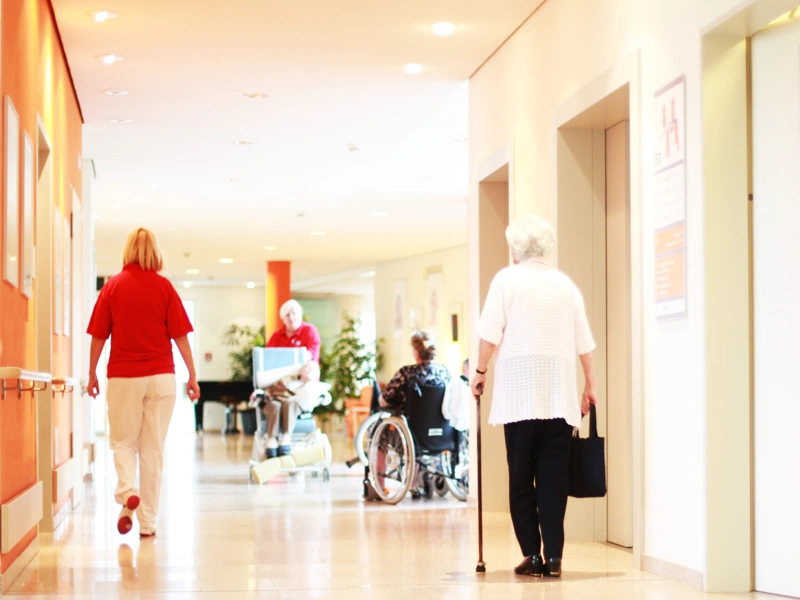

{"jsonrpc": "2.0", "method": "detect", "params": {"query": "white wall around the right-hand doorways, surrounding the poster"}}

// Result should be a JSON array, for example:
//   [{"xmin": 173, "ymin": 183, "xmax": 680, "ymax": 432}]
[{"xmin": 469, "ymin": 0, "xmax": 792, "ymax": 571}]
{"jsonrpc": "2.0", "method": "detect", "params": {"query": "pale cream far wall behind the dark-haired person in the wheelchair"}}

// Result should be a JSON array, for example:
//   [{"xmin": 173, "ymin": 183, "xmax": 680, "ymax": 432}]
[{"xmin": 375, "ymin": 246, "xmax": 469, "ymax": 381}]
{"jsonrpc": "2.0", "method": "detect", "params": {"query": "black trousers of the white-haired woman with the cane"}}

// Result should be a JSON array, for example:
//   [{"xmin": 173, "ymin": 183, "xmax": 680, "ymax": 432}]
[{"xmin": 504, "ymin": 419, "xmax": 572, "ymax": 559}]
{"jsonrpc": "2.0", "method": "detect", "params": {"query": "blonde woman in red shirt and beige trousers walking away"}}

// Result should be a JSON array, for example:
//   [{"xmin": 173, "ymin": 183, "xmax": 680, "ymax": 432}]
[{"xmin": 87, "ymin": 227, "xmax": 200, "ymax": 537}]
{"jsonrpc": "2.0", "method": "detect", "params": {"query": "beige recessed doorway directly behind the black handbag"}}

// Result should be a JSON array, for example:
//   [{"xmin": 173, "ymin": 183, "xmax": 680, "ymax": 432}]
[{"xmin": 556, "ymin": 84, "xmax": 634, "ymax": 548}]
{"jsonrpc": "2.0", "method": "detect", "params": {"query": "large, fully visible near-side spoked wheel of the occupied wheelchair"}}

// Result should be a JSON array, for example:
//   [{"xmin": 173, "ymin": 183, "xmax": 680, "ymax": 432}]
[{"xmin": 369, "ymin": 417, "xmax": 416, "ymax": 504}]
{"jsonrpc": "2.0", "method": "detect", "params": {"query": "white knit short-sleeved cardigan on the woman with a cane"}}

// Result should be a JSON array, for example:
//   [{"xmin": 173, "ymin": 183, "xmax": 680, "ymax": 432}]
[{"xmin": 478, "ymin": 259, "xmax": 595, "ymax": 427}]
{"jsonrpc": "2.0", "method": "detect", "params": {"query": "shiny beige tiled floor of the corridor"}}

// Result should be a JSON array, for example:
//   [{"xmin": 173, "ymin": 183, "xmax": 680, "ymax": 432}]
[{"xmin": 6, "ymin": 405, "xmax": 780, "ymax": 600}]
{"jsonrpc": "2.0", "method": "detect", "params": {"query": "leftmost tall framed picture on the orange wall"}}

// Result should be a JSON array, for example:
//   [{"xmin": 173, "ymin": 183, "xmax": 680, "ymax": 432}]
[{"xmin": 3, "ymin": 96, "xmax": 20, "ymax": 287}]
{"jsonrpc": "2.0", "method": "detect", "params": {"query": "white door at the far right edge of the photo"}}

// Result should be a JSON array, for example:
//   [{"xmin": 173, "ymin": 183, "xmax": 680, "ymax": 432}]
[{"xmin": 742, "ymin": 21, "xmax": 800, "ymax": 597}]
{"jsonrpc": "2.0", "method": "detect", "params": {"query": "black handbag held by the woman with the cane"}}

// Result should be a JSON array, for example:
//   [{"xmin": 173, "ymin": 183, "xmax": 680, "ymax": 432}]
[{"xmin": 569, "ymin": 405, "xmax": 606, "ymax": 498}]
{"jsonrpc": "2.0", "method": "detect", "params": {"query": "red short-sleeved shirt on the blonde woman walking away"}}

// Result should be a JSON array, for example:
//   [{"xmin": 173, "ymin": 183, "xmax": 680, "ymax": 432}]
[{"xmin": 86, "ymin": 264, "xmax": 192, "ymax": 378}]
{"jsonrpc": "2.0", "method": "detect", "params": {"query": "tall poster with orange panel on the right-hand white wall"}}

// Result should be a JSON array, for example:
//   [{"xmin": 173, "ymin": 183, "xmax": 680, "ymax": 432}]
[{"xmin": 653, "ymin": 75, "xmax": 687, "ymax": 321}]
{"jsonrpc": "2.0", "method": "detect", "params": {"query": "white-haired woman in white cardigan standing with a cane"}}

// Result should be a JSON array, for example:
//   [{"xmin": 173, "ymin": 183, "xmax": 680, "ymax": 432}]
[{"xmin": 472, "ymin": 215, "xmax": 597, "ymax": 577}]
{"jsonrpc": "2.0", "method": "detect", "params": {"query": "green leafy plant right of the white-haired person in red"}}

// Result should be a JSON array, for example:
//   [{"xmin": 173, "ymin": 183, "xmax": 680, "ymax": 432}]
[{"xmin": 315, "ymin": 315, "xmax": 383, "ymax": 414}]
